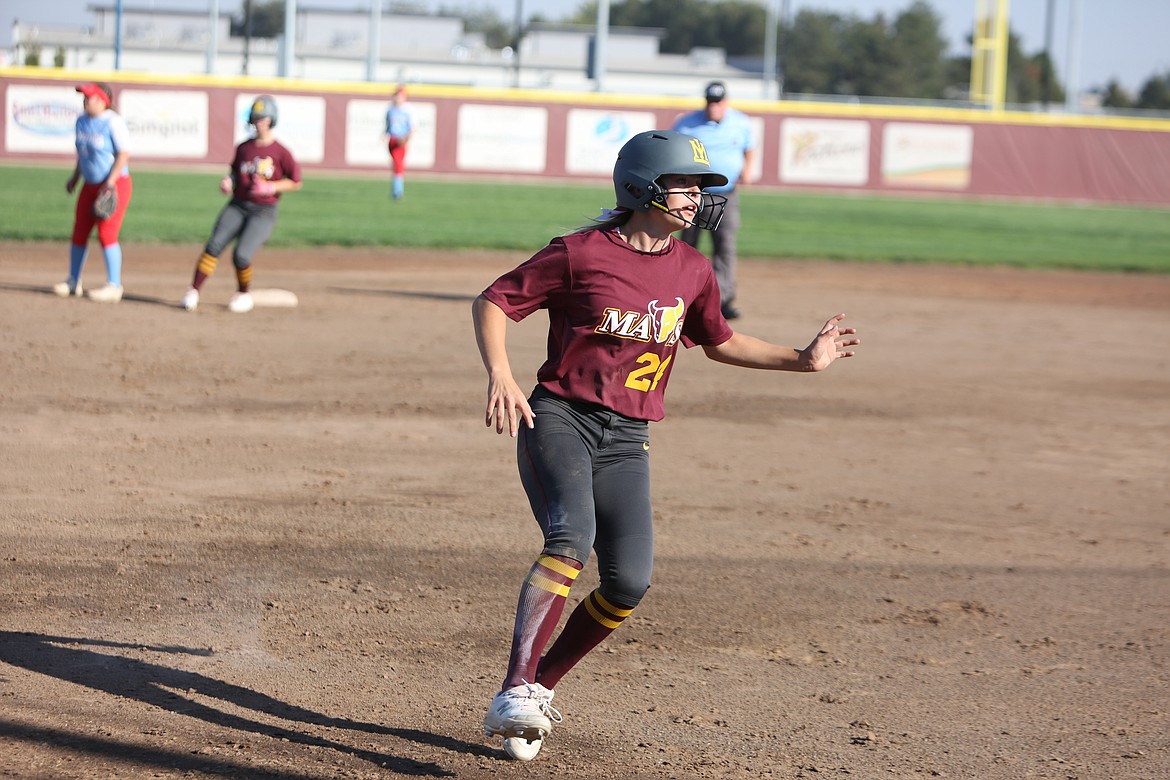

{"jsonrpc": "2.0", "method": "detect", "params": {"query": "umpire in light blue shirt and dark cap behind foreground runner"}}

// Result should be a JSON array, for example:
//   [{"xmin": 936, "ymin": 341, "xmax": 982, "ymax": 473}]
[{"xmin": 674, "ymin": 81, "xmax": 756, "ymax": 319}]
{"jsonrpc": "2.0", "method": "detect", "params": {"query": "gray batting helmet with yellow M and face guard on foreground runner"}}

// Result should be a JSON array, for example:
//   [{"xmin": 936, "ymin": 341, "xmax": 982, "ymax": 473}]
[{"xmin": 613, "ymin": 130, "xmax": 728, "ymax": 230}]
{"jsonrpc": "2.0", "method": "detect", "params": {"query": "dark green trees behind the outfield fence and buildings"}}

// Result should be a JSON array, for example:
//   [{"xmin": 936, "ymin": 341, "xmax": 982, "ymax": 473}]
[{"xmin": 232, "ymin": 0, "xmax": 1170, "ymax": 110}]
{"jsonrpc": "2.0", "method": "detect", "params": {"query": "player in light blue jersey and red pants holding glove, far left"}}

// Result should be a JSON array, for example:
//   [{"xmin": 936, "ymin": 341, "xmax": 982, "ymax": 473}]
[{"xmin": 53, "ymin": 82, "xmax": 133, "ymax": 303}]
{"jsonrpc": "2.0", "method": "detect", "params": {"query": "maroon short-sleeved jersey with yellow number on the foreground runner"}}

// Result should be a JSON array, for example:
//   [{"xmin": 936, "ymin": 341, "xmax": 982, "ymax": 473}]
[{"xmin": 483, "ymin": 230, "xmax": 732, "ymax": 421}]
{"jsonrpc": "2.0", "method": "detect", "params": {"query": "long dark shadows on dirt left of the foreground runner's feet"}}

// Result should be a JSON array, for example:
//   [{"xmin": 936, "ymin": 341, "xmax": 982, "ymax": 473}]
[{"xmin": 0, "ymin": 631, "xmax": 496, "ymax": 780}]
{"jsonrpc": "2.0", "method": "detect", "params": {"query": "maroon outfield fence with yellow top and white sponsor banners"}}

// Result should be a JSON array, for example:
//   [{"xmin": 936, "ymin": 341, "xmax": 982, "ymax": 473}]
[{"xmin": 0, "ymin": 68, "xmax": 1170, "ymax": 207}]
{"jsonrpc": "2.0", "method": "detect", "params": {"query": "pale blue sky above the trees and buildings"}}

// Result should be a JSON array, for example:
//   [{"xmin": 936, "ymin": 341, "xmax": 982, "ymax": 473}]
[{"xmin": 0, "ymin": 0, "xmax": 1170, "ymax": 94}]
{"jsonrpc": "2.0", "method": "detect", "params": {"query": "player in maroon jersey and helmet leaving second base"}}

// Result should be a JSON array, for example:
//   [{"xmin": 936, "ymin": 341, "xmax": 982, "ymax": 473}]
[{"xmin": 183, "ymin": 95, "xmax": 301, "ymax": 313}]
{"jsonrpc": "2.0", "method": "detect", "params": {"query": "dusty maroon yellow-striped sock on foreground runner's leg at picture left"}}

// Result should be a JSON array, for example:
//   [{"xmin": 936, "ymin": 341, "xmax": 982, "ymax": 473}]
[{"xmin": 501, "ymin": 555, "xmax": 581, "ymax": 690}]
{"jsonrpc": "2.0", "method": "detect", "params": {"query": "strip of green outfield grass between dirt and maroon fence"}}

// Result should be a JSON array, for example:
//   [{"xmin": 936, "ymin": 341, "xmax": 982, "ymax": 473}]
[{"xmin": 0, "ymin": 165, "xmax": 1170, "ymax": 274}]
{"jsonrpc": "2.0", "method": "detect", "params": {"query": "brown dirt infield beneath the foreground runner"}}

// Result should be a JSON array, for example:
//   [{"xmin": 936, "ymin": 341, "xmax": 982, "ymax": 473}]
[{"xmin": 0, "ymin": 244, "xmax": 1170, "ymax": 780}]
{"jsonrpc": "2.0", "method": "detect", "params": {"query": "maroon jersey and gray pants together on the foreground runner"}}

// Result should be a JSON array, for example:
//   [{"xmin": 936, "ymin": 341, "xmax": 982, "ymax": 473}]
[{"xmin": 483, "ymin": 230, "xmax": 732, "ymax": 608}]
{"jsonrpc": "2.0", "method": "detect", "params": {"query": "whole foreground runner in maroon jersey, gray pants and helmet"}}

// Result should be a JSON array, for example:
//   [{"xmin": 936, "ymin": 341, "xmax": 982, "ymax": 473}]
[{"xmin": 473, "ymin": 131, "xmax": 859, "ymax": 760}]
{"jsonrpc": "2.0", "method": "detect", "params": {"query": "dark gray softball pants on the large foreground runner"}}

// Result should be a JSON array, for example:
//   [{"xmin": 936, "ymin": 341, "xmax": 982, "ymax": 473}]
[{"xmin": 517, "ymin": 387, "xmax": 654, "ymax": 608}]
